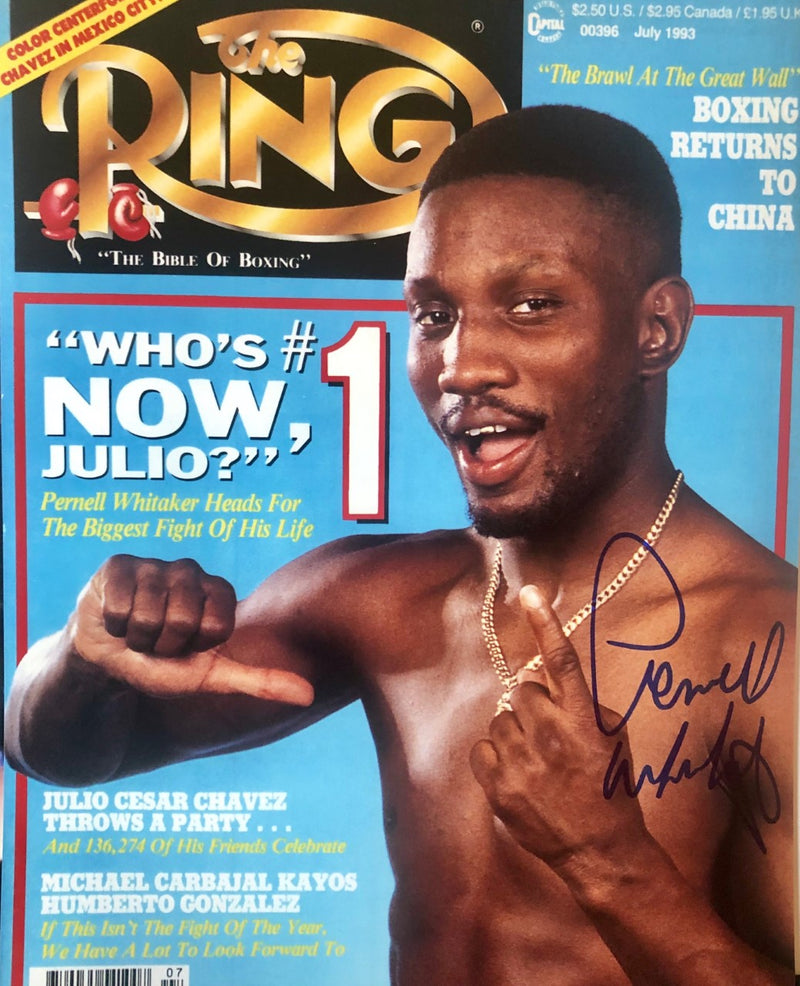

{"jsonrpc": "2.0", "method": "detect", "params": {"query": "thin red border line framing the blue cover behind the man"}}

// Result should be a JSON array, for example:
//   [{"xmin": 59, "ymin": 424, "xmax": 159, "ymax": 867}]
[{"xmin": 6, "ymin": 292, "xmax": 794, "ymax": 986}]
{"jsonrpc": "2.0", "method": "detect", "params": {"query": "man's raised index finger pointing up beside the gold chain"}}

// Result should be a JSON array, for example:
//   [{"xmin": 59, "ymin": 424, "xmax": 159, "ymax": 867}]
[{"xmin": 519, "ymin": 585, "xmax": 591, "ymax": 711}]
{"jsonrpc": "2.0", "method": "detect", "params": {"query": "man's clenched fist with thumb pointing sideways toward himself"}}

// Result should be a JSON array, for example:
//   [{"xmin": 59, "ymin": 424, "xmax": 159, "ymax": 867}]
[{"xmin": 69, "ymin": 555, "xmax": 314, "ymax": 705}]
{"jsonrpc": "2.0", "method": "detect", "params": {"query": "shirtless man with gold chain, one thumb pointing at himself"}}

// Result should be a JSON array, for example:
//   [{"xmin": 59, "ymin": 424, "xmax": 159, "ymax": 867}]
[{"xmin": 7, "ymin": 107, "xmax": 796, "ymax": 986}]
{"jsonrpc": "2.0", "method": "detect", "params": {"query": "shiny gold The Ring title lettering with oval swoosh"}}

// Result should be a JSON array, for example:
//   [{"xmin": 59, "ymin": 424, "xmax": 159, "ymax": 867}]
[{"xmin": 42, "ymin": 10, "xmax": 505, "ymax": 242}]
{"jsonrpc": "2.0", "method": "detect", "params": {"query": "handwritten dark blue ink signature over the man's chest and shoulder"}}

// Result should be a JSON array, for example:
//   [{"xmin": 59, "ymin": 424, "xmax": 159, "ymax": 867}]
[{"xmin": 590, "ymin": 533, "xmax": 786, "ymax": 853}]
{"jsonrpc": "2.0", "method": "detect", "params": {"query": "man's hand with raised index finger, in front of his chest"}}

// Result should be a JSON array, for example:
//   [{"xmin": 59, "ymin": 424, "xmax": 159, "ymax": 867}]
[{"xmin": 470, "ymin": 586, "xmax": 646, "ymax": 869}]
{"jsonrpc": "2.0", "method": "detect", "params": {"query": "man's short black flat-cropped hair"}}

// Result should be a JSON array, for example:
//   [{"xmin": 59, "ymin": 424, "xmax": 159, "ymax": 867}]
[{"xmin": 420, "ymin": 105, "xmax": 681, "ymax": 278}]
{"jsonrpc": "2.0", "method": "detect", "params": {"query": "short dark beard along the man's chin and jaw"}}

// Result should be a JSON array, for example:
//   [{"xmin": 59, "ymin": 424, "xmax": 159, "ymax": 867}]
[{"xmin": 467, "ymin": 380, "xmax": 645, "ymax": 540}]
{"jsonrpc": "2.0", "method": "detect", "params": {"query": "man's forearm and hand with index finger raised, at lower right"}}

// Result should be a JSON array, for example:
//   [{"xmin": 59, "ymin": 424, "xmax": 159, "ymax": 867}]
[{"xmin": 472, "ymin": 592, "xmax": 792, "ymax": 986}]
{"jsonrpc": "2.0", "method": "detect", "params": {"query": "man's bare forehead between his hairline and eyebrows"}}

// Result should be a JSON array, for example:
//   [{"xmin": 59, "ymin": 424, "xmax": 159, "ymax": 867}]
[{"xmin": 406, "ymin": 176, "xmax": 628, "ymax": 282}]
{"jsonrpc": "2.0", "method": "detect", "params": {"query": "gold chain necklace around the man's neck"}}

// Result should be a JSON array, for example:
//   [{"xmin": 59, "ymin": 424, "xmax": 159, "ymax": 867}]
[{"xmin": 481, "ymin": 470, "xmax": 683, "ymax": 715}]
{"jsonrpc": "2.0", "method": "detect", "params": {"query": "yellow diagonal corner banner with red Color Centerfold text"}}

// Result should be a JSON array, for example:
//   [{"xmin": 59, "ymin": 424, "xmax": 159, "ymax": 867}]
[{"xmin": 0, "ymin": 0, "xmax": 178, "ymax": 96}]
